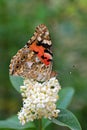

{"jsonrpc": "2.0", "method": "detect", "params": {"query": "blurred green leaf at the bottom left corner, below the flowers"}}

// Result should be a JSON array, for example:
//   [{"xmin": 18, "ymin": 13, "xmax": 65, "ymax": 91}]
[{"xmin": 0, "ymin": 116, "xmax": 35, "ymax": 129}]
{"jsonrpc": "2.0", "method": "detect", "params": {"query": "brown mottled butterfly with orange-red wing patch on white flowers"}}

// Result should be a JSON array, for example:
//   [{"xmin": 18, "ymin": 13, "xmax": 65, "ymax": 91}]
[{"xmin": 9, "ymin": 24, "xmax": 55, "ymax": 81}]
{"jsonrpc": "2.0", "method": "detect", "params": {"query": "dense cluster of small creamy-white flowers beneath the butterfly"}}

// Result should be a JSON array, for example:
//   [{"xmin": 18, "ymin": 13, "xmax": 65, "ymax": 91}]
[{"xmin": 18, "ymin": 77, "xmax": 60, "ymax": 125}]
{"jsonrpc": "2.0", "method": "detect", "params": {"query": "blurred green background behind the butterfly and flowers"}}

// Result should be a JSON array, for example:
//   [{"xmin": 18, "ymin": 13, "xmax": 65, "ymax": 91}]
[{"xmin": 0, "ymin": 0, "xmax": 87, "ymax": 130}]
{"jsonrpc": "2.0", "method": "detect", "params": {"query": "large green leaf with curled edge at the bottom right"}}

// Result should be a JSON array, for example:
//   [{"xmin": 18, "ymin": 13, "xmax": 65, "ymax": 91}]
[{"xmin": 52, "ymin": 109, "xmax": 82, "ymax": 130}]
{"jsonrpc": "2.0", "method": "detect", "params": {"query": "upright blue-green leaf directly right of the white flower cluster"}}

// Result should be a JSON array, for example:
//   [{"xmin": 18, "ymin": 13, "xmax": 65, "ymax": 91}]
[{"xmin": 57, "ymin": 87, "xmax": 74, "ymax": 109}]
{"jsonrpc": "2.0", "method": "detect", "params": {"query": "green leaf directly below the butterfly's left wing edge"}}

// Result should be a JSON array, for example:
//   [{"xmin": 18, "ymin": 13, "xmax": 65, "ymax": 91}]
[{"xmin": 10, "ymin": 76, "xmax": 23, "ymax": 92}]
